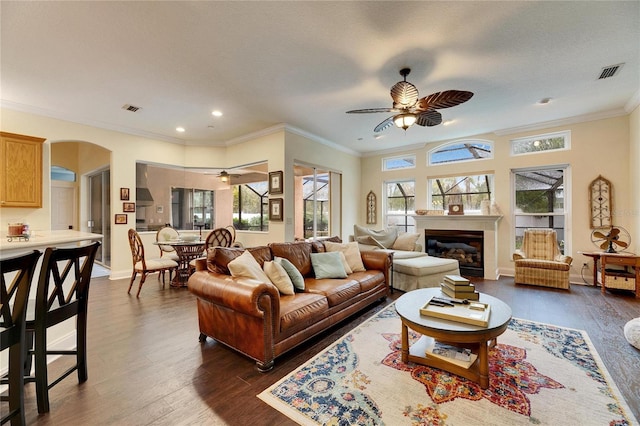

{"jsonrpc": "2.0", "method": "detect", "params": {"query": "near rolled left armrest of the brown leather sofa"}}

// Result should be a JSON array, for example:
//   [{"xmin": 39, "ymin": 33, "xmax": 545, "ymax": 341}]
[{"xmin": 188, "ymin": 270, "xmax": 280, "ymax": 318}]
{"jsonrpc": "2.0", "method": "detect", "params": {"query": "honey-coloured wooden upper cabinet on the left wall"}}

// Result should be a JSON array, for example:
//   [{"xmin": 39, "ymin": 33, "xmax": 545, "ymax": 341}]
[{"xmin": 0, "ymin": 132, "xmax": 45, "ymax": 208}]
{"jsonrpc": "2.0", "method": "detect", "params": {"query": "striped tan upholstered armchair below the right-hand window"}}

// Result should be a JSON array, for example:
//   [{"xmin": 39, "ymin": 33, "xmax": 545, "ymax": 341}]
[{"xmin": 513, "ymin": 229, "xmax": 573, "ymax": 290}]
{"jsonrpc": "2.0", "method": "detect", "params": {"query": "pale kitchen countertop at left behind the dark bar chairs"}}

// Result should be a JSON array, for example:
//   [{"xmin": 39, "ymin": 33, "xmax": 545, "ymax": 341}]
[{"xmin": 0, "ymin": 230, "xmax": 102, "ymax": 258}]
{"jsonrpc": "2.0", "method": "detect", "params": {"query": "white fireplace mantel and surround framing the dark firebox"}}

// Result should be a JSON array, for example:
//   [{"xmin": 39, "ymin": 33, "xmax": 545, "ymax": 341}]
[{"xmin": 412, "ymin": 215, "xmax": 502, "ymax": 280}]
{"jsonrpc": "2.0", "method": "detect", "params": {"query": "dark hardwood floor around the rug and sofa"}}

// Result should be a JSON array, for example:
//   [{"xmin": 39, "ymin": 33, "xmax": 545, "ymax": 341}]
[{"xmin": 10, "ymin": 275, "xmax": 640, "ymax": 425}]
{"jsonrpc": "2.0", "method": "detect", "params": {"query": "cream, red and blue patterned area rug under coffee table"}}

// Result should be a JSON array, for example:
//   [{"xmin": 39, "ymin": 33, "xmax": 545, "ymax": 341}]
[{"xmin": 258, "ymin": 305, "xmax": 637, "ymax": 426}]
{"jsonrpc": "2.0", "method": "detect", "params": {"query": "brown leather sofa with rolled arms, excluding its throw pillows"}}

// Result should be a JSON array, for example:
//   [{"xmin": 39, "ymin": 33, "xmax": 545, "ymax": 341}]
[{"xmin": 189, "ymin": 241, "xmax": 391, "ymax": 372}]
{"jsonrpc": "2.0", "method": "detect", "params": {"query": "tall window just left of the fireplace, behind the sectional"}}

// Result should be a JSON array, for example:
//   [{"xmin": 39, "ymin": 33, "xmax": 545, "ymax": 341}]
[{"xmin": 384, "ymin": 180, "xmax": 416, "ymax": 232}]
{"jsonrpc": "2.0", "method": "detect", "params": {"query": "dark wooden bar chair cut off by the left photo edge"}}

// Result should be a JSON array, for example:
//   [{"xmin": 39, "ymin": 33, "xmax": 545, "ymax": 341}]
[{"xmin": 0, "ymin": 250, "xmax": 41, "ymax": 426}]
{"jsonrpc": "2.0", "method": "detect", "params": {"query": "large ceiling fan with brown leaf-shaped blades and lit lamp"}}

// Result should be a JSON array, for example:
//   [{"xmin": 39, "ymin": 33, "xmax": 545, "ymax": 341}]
[{"xmin": 347, "ymin": 68, "xmax": 473, "ymax": 133}]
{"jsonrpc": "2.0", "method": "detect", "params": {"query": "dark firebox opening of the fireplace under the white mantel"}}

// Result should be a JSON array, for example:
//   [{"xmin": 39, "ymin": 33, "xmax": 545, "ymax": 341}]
[{"xmin": 424, "ymin": 229, "xmax": 484, "ymax": 277}]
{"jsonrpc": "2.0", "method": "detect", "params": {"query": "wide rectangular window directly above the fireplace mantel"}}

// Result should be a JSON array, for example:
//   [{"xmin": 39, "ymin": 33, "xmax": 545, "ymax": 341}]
[{"xmin": 428, "ymin": 174, "xmax": 493, "ymax": 213}]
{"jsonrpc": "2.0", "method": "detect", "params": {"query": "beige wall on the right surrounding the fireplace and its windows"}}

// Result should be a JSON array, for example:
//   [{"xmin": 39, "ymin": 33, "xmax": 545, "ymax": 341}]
[{"xmin": 358, "ymin": 112, "xmax": 640, "ymax": 277}]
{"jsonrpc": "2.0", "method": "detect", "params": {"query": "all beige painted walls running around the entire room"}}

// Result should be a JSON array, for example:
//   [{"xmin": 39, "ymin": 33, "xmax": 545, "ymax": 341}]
[{"xmin": 0, "ymin": 104, "xmax": 640, "ymax": 277}]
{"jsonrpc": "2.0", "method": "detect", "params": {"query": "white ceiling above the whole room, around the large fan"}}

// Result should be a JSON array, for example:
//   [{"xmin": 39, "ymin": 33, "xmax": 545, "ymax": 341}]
[{"xmin": 0, "ymin": 0, "xmax": 640, "ymax": 153}]
